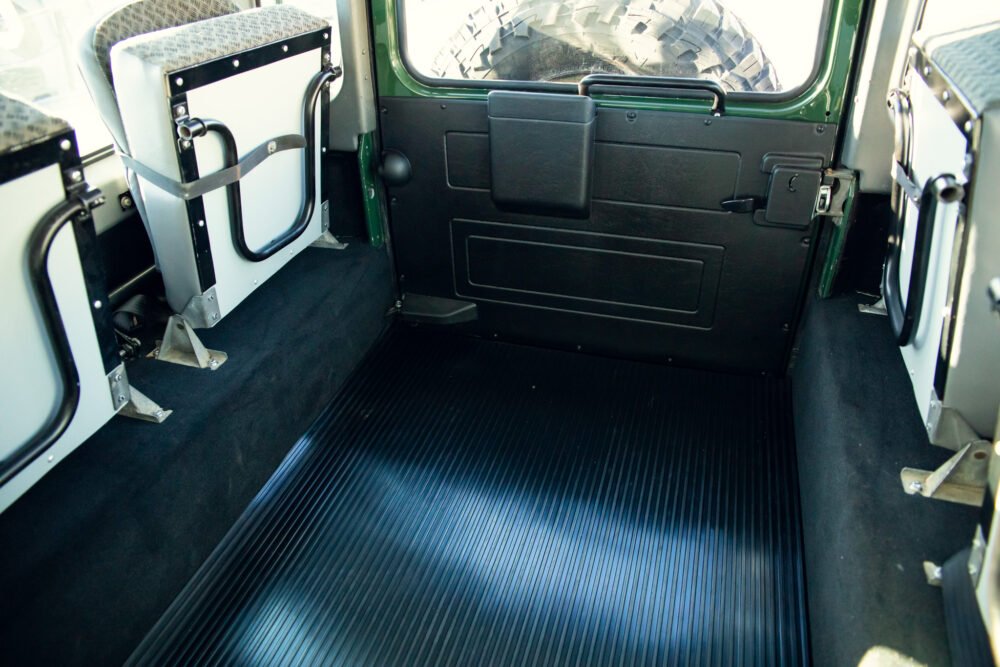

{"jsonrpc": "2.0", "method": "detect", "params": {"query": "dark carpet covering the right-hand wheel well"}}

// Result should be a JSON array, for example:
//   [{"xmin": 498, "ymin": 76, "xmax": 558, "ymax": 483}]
[{"xmin": 793, "ymin": 297, "xmax": 977, "ymax": 667}]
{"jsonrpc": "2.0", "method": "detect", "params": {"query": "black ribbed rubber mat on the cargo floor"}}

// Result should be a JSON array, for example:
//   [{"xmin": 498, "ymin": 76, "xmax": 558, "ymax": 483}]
[{"xmin": 131, "ymin": 327, "xmax": 808, "ymax": 665}]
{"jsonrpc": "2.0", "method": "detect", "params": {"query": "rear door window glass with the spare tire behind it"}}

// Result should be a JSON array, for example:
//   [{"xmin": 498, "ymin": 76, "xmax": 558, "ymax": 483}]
[{"xmin": 400, "ymin": 0, "xmax": 825, "ymax": 93}]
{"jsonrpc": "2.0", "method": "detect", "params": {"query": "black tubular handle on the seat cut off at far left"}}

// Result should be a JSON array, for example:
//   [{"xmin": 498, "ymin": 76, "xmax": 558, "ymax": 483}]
[{"xmin": 0, "ymin": 190, "xmax": 104, "ymax": 485}]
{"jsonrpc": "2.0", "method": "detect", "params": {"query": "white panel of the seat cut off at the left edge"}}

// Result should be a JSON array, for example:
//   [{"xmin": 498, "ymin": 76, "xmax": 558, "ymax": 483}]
[{"xmin": 0, "ymin": 165, "xmax": 124, "ymax": 511}]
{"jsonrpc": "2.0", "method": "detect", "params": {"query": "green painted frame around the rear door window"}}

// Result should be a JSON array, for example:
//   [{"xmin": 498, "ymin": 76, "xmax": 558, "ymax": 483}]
[{"xmin": 371, "ymin": 0, "xmax": 863, "ymax": 123}]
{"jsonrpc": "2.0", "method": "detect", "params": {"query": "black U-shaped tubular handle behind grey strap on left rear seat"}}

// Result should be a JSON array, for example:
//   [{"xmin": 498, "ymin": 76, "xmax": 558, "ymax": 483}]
[{"xmin": 177, "ymin": 67, "xmax": 343, "ymax": 262}]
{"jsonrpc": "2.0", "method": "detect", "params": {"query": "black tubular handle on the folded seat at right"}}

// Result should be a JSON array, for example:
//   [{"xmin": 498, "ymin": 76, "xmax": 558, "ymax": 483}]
[{"xmin": 882, "ymin": 174, "xmax": 965, "ymax": 347}]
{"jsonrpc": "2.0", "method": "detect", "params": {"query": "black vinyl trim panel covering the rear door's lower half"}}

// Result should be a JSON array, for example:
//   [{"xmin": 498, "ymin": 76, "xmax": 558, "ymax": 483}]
[{"xmin": 381, "ymin": 98, "xmax": 836, "ymax": 372}]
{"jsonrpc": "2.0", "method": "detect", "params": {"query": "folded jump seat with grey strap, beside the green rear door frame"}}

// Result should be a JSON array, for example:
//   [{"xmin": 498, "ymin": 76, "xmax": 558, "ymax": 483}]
[{"xmin": 81, "ymin": 0, "xmax": 342, "ymax": 369}]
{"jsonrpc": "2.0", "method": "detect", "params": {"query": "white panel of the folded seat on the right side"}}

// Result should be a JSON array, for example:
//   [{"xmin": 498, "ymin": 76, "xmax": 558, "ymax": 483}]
[{"xmin": 899, "ymin": 74, "xmax": 966, "ymax": 427}]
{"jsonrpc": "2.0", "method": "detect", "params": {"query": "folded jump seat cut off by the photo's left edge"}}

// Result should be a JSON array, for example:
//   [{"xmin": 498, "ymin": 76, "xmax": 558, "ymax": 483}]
[{"xmin": 0, "ymin": 95, "xmax": 137, "ymax": 511}]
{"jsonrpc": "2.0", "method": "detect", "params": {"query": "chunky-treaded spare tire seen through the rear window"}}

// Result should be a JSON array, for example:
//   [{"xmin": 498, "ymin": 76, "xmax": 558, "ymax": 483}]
[{"xmin": 433, "ymin": 0, "xmax": 780, "ymax": 92}]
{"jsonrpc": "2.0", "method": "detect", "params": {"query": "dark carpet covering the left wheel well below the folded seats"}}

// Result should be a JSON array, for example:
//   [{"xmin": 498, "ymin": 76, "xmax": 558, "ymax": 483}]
[{"xmin": 0, "ymin": 244, "xmax": 392, "ymax": 665}]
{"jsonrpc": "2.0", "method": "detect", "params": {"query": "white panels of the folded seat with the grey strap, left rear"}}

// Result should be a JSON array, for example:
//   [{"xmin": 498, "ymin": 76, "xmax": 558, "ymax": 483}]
[{"xmin": 112, "ymin": 24, "xmax": 343, "ymax": 325}]
